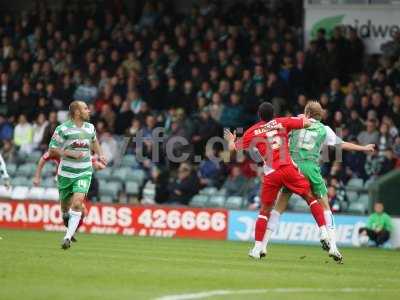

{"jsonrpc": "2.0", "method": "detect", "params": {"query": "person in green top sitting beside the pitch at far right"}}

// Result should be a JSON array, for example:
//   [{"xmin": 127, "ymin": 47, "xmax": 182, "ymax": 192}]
[{"xmin": 359, "ymin": 202, "xmax": 393, "ymax": 247}]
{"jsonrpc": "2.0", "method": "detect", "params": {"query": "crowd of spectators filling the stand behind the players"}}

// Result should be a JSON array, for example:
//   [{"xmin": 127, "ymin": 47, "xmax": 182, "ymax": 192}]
[{"xmin": 0, "ymin": 1, "xmax": 400, "ymax": 211}]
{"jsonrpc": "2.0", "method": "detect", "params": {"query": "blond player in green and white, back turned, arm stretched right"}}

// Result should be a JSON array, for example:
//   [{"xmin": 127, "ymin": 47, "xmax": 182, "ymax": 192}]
[{"xmin": 263, "ymin": 101, "xmax": 375, "ymax": 261}]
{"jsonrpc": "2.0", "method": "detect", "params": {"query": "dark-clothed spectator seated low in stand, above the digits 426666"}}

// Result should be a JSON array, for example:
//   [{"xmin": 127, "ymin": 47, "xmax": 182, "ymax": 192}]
[{"xmin": 167, "ymin": 163, "xmax": 199, "ymax": 205}]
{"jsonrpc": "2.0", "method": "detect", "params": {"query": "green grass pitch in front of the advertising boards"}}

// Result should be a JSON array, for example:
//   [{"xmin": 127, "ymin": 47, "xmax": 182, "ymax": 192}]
[{"xmin": 0, "ymin": 230, "xmax": 400, "ymax": 300}]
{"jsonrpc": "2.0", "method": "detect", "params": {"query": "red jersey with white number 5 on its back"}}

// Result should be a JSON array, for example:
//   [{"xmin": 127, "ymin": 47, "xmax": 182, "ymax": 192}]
[{"xmin": 236, "ymin": 117, "xmax": 304, "ymax": 170}]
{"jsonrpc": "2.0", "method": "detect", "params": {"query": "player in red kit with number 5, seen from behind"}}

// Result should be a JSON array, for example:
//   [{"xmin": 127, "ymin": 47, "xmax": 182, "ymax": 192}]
[{"xmin": 224, "ymin": 102, "xmax": 329, "ymax": 259}]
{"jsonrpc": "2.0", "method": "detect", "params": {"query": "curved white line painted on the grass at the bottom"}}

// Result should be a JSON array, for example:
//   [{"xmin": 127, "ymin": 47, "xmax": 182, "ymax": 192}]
[{"xmin": 155, "ymin": 288, "xmax": 399, "ymax": 300}]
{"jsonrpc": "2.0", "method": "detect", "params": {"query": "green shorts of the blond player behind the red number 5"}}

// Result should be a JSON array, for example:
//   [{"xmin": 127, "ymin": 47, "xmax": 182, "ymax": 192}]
[{"xmin": 282, "ymin": 161, "xmax": 328, "ymax": 198}]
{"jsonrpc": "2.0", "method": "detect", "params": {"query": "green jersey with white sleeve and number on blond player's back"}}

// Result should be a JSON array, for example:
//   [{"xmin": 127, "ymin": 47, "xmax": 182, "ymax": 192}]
[{"xmin": 289, "ymin": 119, "xmax": 343, "ymax": 163}]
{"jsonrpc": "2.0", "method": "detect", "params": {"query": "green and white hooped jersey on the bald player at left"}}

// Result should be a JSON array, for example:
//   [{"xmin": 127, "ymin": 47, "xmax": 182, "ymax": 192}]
[{"xmin": 49, "ymin": 120, "xmax": 96, "ymax": 178}]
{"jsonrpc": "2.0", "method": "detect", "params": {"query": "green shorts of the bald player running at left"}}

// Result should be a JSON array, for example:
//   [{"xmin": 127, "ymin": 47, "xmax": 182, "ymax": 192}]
[{"xmin": 58, "ymin": 175, "xmax": 92, "ymax": 202}]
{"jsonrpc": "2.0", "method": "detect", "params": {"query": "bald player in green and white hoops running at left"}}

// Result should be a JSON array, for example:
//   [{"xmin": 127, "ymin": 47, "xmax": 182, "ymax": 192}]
[{"xmin": 49, "ymin": 101, "xmax": 107, "ymax": 249}]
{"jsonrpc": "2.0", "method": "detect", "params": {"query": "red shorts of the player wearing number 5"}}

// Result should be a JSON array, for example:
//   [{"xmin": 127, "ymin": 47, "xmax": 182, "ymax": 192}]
[{"xmin": 261, "ymin": 165, "xmax": 311, "ymax": 205}]
